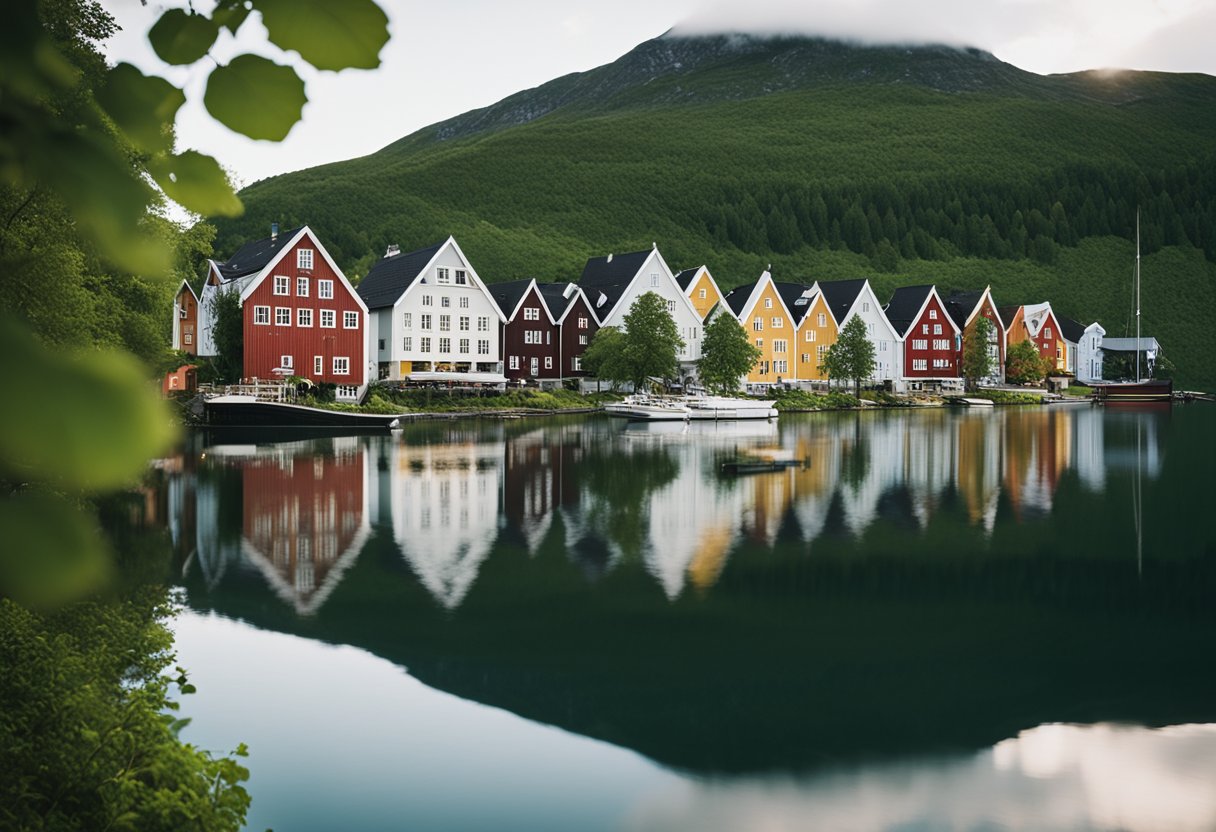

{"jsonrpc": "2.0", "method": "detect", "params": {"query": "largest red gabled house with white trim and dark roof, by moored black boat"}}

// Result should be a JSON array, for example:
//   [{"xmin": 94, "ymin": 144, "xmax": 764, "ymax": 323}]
[{"xmin": 199, "ymin": 226, "xmax": 368, "ymax": 400}]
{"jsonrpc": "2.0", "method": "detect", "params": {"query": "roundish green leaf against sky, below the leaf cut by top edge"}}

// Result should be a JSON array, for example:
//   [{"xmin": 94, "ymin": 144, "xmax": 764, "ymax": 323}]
[{"xmin": 203, "ymin": 55, "xmax": 308, "ymax": 141}]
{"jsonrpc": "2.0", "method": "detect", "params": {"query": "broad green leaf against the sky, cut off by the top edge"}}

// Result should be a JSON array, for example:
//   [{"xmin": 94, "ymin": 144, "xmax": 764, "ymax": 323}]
[{"xmin": 253, "ymin": 0, "xmax": 388, "ymax": 71}]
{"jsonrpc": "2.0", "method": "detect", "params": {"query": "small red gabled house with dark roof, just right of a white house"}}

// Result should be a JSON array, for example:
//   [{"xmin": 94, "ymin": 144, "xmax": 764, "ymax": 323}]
[{"xmin": 885, "ymin": 286, "xmax": 962, "ymax": 390}]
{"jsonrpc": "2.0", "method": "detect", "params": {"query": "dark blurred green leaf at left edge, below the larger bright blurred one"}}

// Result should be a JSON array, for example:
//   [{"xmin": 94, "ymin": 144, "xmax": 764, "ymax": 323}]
[{"xmin": 0, "ymin": 491, "xmax": 109, "ymax": 607}]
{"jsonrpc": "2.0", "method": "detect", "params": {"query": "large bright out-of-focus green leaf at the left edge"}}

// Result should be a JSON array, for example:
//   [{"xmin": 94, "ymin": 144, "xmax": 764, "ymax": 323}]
[{"xmin": 0, "ymin": 319, "xmax": 174, "ymax": 486}]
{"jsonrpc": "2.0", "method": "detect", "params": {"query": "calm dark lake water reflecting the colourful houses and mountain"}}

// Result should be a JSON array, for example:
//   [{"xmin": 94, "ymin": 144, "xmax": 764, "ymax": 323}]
[{"xmin": 154, "ymin": 405, "xmax": 1216, "ymax": 832}]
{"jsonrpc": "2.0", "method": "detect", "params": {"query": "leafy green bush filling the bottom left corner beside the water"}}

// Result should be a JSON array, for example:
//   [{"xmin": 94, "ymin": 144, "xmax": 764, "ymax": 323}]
[{"xmin": 0, "ymin": 590, "xmax": 249, "ymax": 832}]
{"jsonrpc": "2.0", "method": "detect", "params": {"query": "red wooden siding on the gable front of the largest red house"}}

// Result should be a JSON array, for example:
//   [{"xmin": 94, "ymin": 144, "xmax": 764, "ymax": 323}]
[{"xmin": 243, "ymin": 235, "xmax": 367, "ymax": 386}]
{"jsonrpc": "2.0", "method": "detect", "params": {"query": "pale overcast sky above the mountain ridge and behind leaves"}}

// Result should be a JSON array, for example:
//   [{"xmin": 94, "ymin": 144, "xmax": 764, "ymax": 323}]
[{"xmin": 102, "ymin": 0, "xmax": 1216, "ymax": 193}]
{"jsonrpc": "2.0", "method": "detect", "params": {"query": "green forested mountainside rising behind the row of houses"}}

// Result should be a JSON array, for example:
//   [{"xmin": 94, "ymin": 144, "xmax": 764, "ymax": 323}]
[{"xmin": 216, "ymin": 36, "xmax": 1216, "ymax": 387}]
